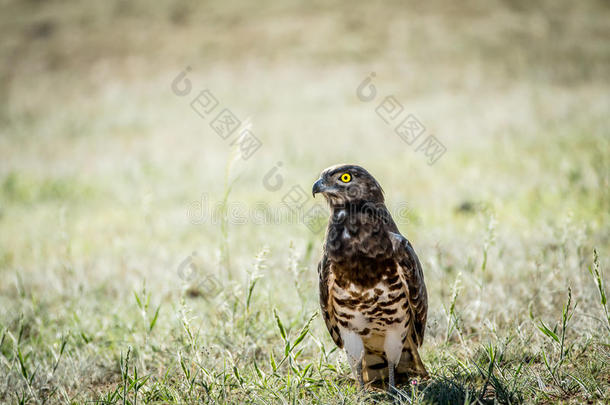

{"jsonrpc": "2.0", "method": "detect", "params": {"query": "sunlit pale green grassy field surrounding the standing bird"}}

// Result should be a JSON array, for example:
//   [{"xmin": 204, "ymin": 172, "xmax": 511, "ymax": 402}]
[{"xmin": 0, "ymin": 1, "xmax": 610, "ymax": 404}]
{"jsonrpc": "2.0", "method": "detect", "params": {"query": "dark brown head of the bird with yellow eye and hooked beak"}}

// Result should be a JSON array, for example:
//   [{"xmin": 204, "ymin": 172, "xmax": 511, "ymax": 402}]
[{"xmin": 311, "ymin": 164, "xmax": 383, "ymax": 208}]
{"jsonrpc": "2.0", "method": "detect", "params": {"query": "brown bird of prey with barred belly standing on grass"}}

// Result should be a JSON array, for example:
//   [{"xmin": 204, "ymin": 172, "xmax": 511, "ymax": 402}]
[{"xmin": 312, "ymin": 165, "xmax": 428, "ymax": 392}]
